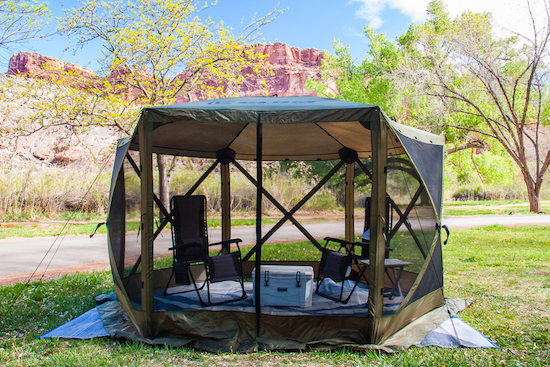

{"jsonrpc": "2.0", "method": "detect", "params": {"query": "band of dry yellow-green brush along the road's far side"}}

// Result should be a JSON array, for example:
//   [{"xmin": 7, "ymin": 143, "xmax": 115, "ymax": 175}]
[{"xmin": 5, "ymin": 152, "xmax": 550, "ymax": 221}]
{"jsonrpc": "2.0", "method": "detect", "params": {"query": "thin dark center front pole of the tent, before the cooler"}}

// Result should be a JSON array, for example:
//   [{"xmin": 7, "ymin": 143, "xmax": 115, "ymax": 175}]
[{"xmin": 254, "ymin": 113, "xmax": 263, "ymax": 338}]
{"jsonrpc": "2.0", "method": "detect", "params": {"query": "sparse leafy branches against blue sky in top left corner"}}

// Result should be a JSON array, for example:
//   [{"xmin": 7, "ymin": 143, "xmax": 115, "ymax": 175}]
[{"xmin": 0, "ymin": 0, "xmax": 50, "ymax": 57}]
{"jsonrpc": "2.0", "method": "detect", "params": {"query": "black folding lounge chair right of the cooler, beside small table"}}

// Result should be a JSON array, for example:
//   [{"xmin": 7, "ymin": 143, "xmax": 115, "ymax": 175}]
[{"xmin": 315, "ymin": 237, "xmax": 367, "ymax": 304}]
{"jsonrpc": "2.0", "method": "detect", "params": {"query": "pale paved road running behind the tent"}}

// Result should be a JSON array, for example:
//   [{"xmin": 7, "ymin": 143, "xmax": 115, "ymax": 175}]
[{"xmin": 0, "ymin": 215, "xmax": 550, "ymax": 283}]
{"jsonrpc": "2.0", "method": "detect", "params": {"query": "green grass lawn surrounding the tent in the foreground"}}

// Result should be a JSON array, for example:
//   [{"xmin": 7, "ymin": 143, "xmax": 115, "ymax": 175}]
[{"xmin": 0, "ymin": 226, "xmax": 550, "ymax": 366}]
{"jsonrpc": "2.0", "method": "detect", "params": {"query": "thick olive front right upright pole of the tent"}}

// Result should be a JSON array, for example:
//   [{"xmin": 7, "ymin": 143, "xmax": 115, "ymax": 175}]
[{"xmin": 368, "ymin": 111, "xmax": 388, "ymax": 344}]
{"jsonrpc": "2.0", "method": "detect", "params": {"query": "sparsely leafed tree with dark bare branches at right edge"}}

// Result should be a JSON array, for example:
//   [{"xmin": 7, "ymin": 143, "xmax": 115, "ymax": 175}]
[{"xmin": 402, "ymin": 0, "xmax": 550, "ymax": 212}]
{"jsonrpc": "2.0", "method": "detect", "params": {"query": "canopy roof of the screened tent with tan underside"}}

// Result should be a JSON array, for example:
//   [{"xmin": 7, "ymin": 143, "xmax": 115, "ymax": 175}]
[{"xmin": 130, "ymin": 96, "xmax": 442, "ymax": 161}]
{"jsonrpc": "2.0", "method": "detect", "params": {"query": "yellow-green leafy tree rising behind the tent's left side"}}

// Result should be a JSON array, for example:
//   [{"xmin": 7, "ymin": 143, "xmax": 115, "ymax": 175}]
[{"xmin": 3, "ymin": 0, "xmax": 281, "ymax": 214}]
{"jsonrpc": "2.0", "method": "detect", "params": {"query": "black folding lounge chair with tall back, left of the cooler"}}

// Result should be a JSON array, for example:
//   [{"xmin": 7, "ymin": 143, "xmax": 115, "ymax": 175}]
[{"xmin": 164, "ymin": 195, "xmax": 246, "ymax": 306}]
